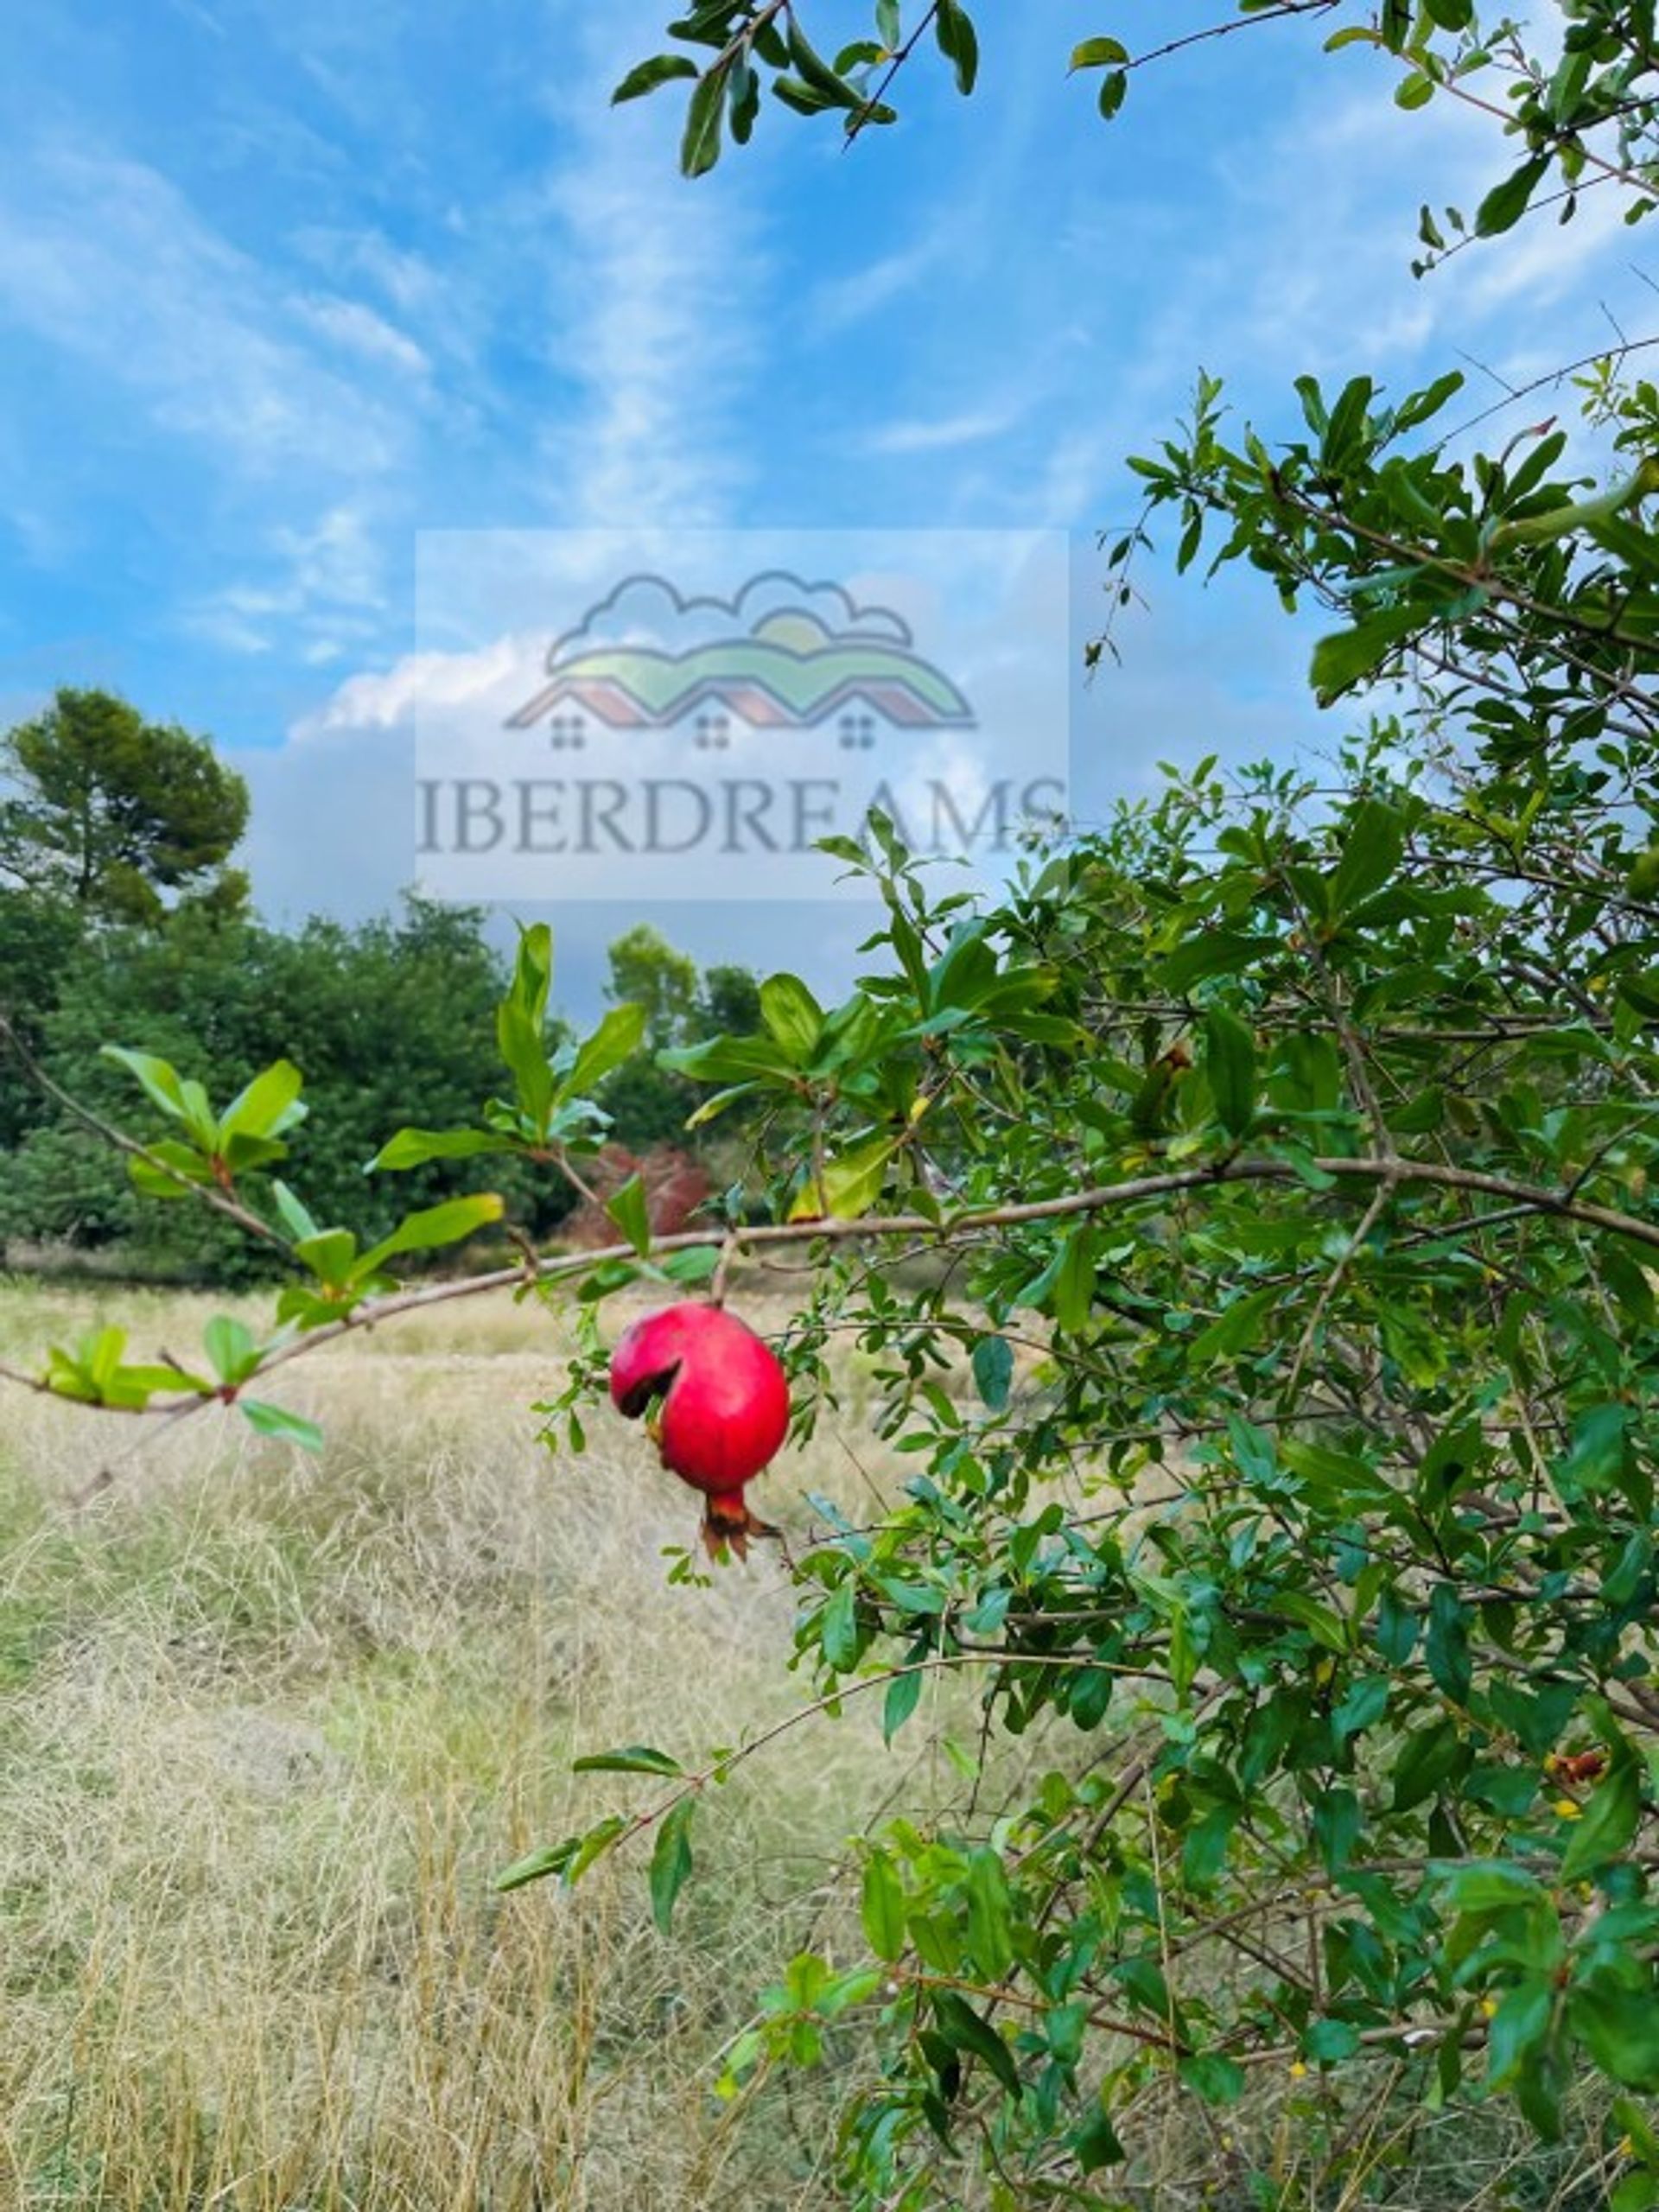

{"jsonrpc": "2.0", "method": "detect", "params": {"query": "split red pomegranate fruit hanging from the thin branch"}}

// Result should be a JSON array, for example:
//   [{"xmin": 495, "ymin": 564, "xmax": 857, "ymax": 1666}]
[{"xmin": 611, "ymin": 1300, "xmax": 790, "ymax": 1560}]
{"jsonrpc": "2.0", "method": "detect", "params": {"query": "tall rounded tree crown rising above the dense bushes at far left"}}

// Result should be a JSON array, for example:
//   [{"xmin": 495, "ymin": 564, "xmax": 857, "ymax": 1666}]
[{"xmin": 0, "ymin": 688, "xmax": 248, "ymax": 923}]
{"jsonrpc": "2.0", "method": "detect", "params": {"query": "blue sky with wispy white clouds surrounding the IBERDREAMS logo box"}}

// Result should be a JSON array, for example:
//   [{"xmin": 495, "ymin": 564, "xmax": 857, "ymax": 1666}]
[{"xmin": 0, "ymin": 0, "xmax": 1652, "ymax": 1004}]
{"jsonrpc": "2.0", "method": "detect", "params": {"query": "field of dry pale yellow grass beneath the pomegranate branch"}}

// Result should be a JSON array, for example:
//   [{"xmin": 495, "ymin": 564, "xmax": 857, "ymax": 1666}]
[{"xmin": 0, "ymin": 1285, "xmax": 969, "ymax": 2212}]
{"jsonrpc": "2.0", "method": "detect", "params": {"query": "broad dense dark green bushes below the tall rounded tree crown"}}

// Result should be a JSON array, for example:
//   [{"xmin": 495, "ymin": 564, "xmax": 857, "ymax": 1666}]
[{"xmin": 0, "ymin": 898, "xmax": 573, "ymax": 1281}]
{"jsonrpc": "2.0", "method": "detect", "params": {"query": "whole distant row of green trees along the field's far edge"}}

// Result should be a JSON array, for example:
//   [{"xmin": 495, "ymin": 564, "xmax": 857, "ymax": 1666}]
[{"xmin": 0, "ymin": 688, "xmax": 757, "ymax": 1285}]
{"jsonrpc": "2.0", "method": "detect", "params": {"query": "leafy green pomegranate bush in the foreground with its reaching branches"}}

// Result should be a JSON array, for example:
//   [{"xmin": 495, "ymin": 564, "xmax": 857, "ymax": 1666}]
[{"xmin": 10, "ymin": 0, "xmax": 1659, "ymax": 2212}]
